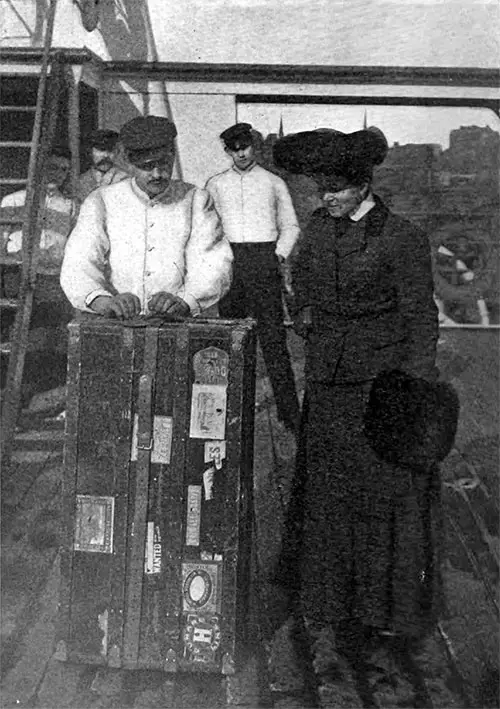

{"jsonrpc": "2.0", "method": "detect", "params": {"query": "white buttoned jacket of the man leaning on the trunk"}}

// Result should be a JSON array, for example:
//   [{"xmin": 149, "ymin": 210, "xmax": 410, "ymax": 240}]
[{"xmin": 61, "ymin": 178, "xmax": 233, "ymax": 315}]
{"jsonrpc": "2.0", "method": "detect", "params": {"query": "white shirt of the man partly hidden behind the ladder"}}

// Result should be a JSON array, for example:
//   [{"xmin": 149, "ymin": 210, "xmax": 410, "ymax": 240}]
[{"xmin": 0, "ymin": 190, "xmax": 77, "ymax": 275}]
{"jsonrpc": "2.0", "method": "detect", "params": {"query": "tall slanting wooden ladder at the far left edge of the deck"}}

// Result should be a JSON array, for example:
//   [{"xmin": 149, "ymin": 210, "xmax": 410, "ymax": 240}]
[{"xmin": 0, "ymin": 0, "xmax": 64, "ymax": 462}]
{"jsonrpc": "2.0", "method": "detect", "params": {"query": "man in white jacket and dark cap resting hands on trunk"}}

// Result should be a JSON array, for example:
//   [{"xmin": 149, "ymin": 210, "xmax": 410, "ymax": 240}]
[{"xmin": 61, "ymin": 116, "xmax": 232, "ymax": 319}]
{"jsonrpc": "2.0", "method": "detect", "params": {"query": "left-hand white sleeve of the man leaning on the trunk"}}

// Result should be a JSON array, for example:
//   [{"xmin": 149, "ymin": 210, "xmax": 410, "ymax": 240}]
[{"xmin": 61, "ymin": 191, "xmax": 114, "ymax": 310}]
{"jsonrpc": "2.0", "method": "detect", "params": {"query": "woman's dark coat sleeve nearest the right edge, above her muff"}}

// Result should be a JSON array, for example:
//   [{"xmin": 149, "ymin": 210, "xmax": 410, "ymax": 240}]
[{"xmin": 394, "ymin": 222, "xmax": 439, "ymax": 381}]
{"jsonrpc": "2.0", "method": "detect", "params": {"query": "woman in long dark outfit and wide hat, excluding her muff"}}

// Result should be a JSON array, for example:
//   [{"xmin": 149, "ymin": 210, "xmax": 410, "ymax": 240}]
[{"xmin": 275, "ymin": 130, "xmax": 448, "ymax": 704}]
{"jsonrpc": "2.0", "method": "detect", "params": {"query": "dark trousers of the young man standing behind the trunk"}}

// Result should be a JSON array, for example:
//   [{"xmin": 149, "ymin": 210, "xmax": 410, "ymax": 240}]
[{"xmin": 219, "ymin": 242, "xmax": 299, "ymax": 425}]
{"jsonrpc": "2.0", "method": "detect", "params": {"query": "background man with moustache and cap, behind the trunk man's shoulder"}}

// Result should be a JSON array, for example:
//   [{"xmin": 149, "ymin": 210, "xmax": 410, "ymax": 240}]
[{"xmin": 76, "ymin": 130, "xmax": 128, "ymax": 204}]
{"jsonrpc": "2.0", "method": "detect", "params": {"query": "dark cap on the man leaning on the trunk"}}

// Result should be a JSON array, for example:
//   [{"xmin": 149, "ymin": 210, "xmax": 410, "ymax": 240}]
[{"xmin": 120, "ymin": 116, "xmax": 177, "ymax": 162}]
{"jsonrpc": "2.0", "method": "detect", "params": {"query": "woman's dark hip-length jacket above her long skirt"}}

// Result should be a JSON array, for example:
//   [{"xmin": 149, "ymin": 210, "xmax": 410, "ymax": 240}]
[{"xmin": 293, "ymin": 194, "xmax": 438, "ymax": 384}]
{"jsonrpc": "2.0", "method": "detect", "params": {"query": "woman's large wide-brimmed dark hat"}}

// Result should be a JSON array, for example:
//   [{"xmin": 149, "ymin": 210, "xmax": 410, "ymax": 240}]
[{"xmin": 273, "ymin": 128, "xmax": 389, "ymax": 192}]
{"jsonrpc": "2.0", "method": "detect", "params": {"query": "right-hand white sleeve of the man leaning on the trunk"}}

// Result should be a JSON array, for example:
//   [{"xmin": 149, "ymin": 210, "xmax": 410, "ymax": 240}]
[{"xmin": 178, "ymin": 189, "xmax": 233, "ymax": 315}]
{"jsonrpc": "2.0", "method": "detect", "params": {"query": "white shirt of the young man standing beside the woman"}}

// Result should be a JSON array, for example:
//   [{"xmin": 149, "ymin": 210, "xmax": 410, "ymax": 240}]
[{"xmin": 205, "ymin": 164, "xmax": 300, "ymax": 258}]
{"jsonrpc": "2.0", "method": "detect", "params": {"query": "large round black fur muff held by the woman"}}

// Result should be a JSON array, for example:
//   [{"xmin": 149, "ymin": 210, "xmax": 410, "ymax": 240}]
[{"xmin": 364, "ymin": 370, "xmax": 460, "ymax": 470}]
